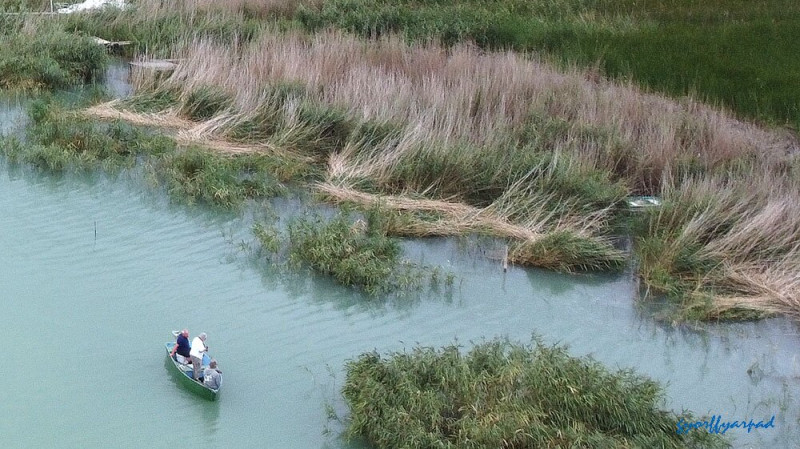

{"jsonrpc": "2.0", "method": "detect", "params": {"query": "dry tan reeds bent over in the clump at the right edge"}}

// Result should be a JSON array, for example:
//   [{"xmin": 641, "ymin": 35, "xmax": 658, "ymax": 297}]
[{"xmin": 645, "ymin": 170, "xmax": 800, "ymax": 319}]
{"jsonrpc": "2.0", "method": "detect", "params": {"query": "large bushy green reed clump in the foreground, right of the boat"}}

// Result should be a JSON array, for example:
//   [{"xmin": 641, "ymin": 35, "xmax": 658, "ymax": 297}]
[{"xmin": 343, "ymin": 340, "xmax": 727, "ymax": 449}]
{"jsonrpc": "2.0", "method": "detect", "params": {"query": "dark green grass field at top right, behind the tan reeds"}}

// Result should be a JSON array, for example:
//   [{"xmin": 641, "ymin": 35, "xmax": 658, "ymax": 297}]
[{"xmin": 297, "ymin": 0, "xmax": 800, "ymax": 127}]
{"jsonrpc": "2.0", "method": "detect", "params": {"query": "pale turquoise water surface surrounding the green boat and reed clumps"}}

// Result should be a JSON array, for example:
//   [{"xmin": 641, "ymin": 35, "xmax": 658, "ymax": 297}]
[{"xmin": 0, "ymin": 65, "xmax": 800, "ymax": 448}]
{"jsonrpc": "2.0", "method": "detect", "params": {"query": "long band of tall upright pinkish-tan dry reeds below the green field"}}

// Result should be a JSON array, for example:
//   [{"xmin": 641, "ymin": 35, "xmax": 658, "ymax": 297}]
[{"xmin": 138, "ymin": 28, "xmax": 796, "ymax": 188}]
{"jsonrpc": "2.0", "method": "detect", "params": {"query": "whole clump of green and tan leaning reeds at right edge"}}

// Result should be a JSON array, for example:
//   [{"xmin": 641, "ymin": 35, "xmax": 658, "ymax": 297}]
[{"xmin": 636, "ymin": 171, "xmax": 800, "ymax": 319}]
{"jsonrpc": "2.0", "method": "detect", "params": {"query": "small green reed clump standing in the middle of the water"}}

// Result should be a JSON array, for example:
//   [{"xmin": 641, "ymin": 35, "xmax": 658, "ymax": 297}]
[{"xmin": 254, "ymin": 211, "xmax": 454, "ymax": 296}]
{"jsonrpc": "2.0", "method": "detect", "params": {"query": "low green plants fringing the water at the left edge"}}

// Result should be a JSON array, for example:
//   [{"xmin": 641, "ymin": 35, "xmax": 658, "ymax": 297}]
[{"xmin": 0, "ymin": 97, "xmax": 294, "ymax": 207}]
